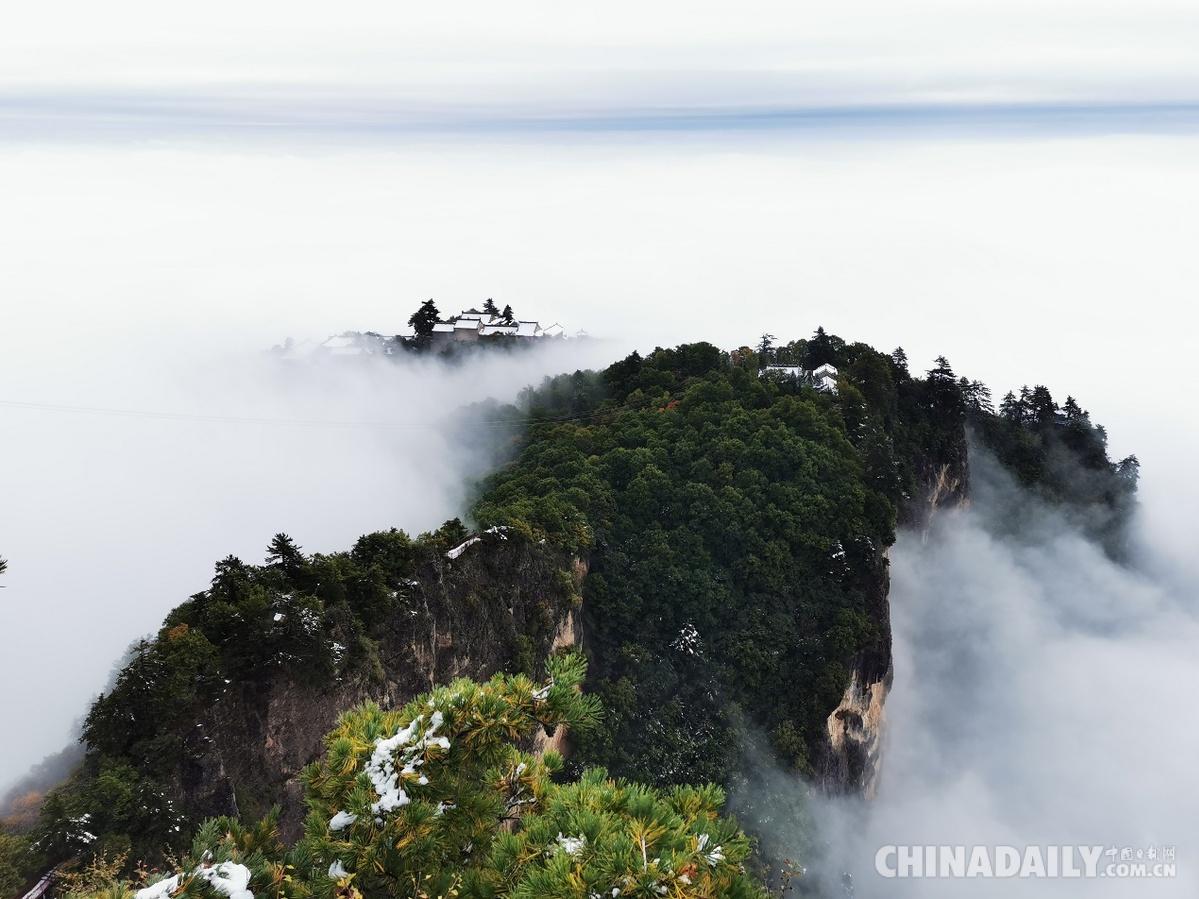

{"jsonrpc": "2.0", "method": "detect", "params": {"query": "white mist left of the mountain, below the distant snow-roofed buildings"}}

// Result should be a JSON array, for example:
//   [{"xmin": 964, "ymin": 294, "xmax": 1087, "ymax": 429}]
[{"xmin": 0, "ymin": 334, "xmax": 617, "ymax": 790}]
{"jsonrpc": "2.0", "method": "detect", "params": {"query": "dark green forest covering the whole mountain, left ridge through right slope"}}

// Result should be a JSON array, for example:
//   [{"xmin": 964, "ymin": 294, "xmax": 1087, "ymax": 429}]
[{"xmin": 0, "ymin": 330, "xmax": 1137, "ymax": 894}]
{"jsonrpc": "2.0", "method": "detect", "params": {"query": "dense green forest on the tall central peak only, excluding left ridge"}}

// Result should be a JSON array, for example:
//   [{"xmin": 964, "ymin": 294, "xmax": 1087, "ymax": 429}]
[{"xmin": 474, "ymin": 332, "xmax": 965, "ymax": 784}]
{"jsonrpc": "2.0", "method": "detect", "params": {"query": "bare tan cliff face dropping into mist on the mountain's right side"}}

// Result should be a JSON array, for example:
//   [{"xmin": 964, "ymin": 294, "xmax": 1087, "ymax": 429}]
[{"xmin": 819, "ymin": 429, "xmax": 969, "ymax": 798}]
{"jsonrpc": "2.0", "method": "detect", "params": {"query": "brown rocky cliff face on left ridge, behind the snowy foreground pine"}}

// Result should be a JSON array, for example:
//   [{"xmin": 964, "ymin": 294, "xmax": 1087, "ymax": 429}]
[{"xmin": 173, "ymin": 535, "xmax": 586, "ymax": 838}]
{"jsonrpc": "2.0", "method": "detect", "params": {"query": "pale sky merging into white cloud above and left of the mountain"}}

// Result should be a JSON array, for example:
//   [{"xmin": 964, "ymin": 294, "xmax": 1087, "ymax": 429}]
[{"xmin": 0, "ymin": 0, "xmax": 1199, "ymax": 858}]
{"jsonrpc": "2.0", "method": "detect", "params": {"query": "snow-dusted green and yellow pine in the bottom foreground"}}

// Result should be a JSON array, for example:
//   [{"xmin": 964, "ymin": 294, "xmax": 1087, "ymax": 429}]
[{"xmin": 91, "ymin": 653, "xmax": 767, "ymax": 899}]
